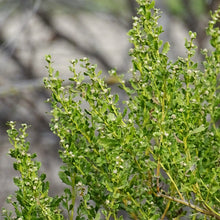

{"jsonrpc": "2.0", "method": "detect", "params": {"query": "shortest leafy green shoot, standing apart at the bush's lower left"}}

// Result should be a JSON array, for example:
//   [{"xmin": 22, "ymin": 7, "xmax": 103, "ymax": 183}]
[{"xmin": 2, "ymin": 122, "xmax": 63, "ymax": 220}]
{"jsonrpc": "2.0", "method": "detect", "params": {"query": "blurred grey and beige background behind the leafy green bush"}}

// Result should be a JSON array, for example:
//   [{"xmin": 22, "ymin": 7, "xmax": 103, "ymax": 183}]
[{"xmin": 0, "ymin": 0, "xmax": 220, "ymax": 217}]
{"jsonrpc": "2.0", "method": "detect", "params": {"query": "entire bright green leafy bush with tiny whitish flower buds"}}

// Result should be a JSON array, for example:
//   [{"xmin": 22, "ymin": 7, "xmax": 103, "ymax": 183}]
[{"xmin": 3, "ymin": 0, "xmax": 220, "ymax": 220}]
